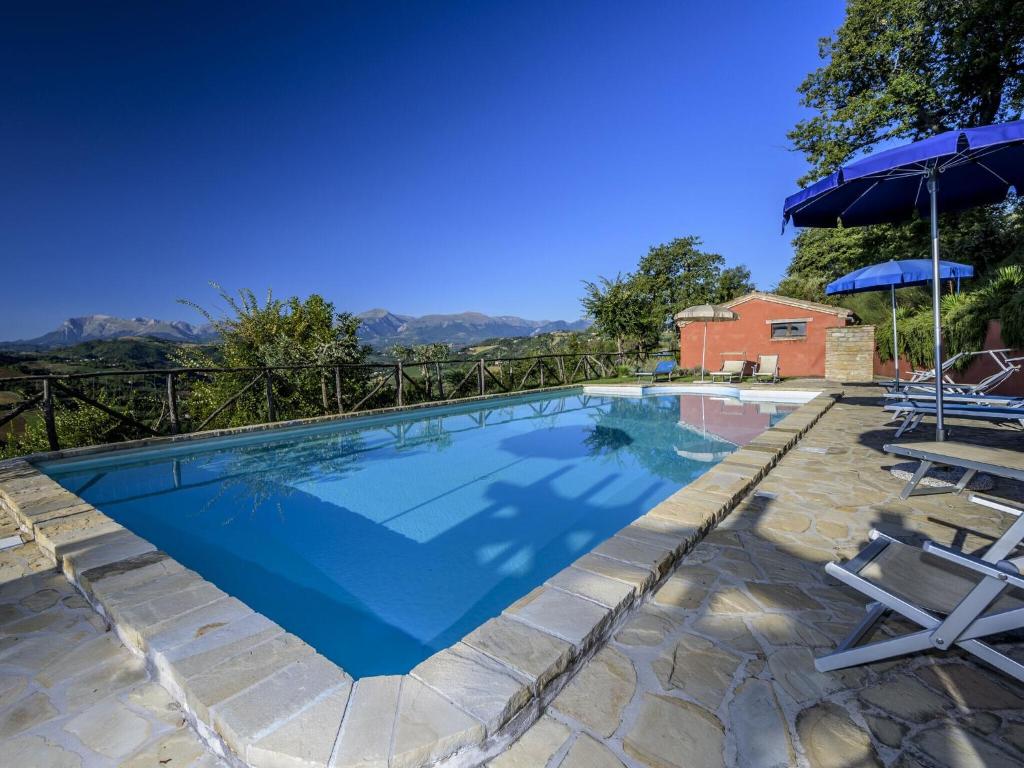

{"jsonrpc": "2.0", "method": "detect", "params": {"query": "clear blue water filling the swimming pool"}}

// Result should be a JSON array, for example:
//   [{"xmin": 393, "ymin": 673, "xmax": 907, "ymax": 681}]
[{"xmin": 41, "ymin": 392, "xmax": 794, "ymax": 677}]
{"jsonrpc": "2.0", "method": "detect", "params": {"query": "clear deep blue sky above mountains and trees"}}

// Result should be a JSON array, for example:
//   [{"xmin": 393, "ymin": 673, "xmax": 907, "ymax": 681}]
[{"xmin": 0, "ymin": 0, "xmax": 843, "ymax": 339}]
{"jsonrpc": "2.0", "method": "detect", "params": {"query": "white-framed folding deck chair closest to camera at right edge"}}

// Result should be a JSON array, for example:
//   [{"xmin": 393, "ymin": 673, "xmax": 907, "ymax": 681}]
[{"xmin": 814, "ymin": 489, "xmax": 1024, "ymax": 682}]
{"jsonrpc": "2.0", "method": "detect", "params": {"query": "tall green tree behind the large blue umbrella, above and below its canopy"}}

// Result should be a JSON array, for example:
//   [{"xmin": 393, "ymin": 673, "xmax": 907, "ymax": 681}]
[{"xmin": 776, "ymin": 0, "xmax": 1024, "ymax": 301}]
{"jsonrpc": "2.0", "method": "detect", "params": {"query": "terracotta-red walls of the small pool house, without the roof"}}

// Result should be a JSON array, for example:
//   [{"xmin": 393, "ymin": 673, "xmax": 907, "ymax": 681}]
[{"xmin": 679, "ymin": 298, "xmax": 846, "ymax": 377}]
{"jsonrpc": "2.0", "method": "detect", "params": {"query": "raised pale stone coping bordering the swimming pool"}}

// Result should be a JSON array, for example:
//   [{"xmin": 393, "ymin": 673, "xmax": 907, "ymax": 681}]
[{"xmin": 0, "ymin": 387, "xmax": 842, "ymax": 768}]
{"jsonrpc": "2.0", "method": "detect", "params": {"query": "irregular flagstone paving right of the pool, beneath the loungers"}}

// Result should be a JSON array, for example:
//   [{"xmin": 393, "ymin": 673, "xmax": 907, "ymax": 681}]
[{"xmin": 490, "ymin": 389, "xmax": 1024, "ymax": 768}]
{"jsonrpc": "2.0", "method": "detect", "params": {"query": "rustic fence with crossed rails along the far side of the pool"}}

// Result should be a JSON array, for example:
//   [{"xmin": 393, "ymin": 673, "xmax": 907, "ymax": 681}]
[{"xmin": 0, "ymin": 350, "xmax": 676, "ymax": 451}]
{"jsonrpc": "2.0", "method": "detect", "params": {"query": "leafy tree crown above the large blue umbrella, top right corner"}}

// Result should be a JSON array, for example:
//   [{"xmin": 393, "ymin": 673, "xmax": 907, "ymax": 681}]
[{"xmin": 790, "ymin": 0, "xmax": 1024, "ymax": 182}]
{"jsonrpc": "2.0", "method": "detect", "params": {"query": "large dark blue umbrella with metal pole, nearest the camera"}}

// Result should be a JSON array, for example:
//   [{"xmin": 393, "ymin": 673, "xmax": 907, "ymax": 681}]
[{"xmin": 782, "ymin": 120, "xmax": 1024, "ymax": 440}]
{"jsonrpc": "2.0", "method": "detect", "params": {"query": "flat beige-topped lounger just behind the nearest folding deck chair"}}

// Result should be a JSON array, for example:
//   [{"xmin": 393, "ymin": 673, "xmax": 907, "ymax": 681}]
[{"xmin": 882, "ymin": 441, "xmax": 1024, "ymax": 499}]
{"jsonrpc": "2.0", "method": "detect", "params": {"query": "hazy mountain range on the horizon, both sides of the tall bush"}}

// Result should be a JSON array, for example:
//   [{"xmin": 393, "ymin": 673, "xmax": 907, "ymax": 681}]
[{"xmin": 4, "ymin": 309, "xmax": 590, "ymax": 350}]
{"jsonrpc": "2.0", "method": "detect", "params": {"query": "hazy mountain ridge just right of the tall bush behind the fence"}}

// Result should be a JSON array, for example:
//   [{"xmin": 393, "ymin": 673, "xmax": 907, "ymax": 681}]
[{"xmin": 358, "ymin": 309, "xmax": 590, "ymax": 349}]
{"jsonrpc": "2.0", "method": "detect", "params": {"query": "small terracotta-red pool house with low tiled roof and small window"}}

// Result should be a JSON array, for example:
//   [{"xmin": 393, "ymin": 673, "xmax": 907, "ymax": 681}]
[{"xmin": 677, "ymin": 291, "xmax": 854, "ymax": 377}]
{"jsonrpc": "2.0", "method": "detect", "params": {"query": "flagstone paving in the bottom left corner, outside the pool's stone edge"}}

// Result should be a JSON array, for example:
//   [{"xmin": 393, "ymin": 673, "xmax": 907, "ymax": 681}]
[{"xmin": 0, "ymin": 512, "xmax": 224, "ymax": 768}]
